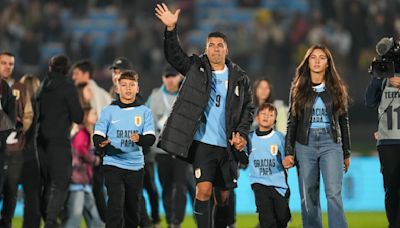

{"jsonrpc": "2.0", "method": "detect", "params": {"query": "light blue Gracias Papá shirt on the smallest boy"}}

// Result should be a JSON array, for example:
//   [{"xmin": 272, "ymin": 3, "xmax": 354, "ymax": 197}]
[{"xmin": 249, "ymin": 130, "xmax": 289, "ymax": 196}]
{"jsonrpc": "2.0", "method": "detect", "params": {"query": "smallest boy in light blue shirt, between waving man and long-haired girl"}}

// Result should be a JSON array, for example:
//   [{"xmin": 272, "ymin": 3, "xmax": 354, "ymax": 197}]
[{"xmin": 249, "ymin": 103, "xmax": 291, "ymax": 228}]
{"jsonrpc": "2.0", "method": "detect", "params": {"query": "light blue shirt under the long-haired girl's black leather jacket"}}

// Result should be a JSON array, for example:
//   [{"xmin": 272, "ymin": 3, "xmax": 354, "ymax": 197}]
[{"xmin": 310, "ymin": 83, "xmax": 330, "ymax": 128}]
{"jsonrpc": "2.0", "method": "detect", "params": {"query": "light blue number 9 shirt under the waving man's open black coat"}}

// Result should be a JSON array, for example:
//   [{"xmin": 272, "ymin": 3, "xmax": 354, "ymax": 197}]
[{"xmin": 194, "ymin": 65, "xmax": 229, "ymax": 147}]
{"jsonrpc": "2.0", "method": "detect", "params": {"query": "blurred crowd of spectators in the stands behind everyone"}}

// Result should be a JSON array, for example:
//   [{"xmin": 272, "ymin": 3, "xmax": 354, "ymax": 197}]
[{"xmin": 0, "ymin": 0, "xmax": 400, "ymax": 101}]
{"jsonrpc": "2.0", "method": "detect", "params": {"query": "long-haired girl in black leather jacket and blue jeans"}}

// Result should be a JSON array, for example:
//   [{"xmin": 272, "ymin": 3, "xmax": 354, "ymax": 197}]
[{"xmin": 284, "ymin": 45, "xmax": 350, "ymax": 228}]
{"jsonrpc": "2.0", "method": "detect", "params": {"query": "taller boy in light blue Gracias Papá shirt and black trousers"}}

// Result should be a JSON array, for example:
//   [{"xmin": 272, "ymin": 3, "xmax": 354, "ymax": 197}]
[{"xmin": 93, "ymin": 71, "xmax": 155, "ymax": 228}]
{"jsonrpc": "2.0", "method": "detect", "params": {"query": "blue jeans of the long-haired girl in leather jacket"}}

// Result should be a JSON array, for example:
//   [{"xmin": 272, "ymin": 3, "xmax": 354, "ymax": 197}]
[{"xmin": 295, "ymin": 128, "xmax": 347, "ymax": 228}]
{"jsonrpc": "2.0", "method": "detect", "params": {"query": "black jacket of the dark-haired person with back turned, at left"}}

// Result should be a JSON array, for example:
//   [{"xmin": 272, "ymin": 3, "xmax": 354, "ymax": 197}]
[{"xmin": 37, "ymin": 72, "xmax": 83, "ymax": 146}]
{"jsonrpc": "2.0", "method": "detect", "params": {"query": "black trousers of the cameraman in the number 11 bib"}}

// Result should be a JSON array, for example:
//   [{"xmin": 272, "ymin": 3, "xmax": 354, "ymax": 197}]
[{"xmin": 378, "ymin": 144, "xmax": 400, "ymax": 228}]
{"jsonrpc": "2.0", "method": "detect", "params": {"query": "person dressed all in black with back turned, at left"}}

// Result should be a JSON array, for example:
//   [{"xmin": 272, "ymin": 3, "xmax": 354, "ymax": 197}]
[{"xmin": 37, "ymin": 55, "xmax": 83, "ymax": 228}]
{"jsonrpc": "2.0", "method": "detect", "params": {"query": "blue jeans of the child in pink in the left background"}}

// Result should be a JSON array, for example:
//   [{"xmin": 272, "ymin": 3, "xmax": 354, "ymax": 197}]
[{"xmin": 63, "ymin": 190, "xmax": 105, "ymax": 228}]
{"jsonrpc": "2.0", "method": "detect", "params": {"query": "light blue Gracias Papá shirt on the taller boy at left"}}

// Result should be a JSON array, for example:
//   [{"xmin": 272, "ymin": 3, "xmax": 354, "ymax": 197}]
[{"xmin": 94, "ymin": 105, "xmax": 154, "ymax": 170}]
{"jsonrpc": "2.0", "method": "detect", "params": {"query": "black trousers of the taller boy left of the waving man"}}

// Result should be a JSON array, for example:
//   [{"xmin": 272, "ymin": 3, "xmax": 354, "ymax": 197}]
[{"xmin": 103, "ymin": 165, "xmax": 143, "ymax": 228}]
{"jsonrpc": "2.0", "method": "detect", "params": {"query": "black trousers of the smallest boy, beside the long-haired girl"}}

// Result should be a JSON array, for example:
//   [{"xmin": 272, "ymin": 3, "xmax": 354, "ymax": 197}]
[{"xmin": 251, "ymin": 184, "xmax": 291, "ymax": 228}]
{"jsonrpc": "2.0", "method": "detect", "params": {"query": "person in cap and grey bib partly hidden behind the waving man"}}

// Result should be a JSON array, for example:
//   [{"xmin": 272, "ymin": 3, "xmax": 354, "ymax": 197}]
[{"xmin": 146, "ymin": 65, "xmax": 185, "ymax": 228}]
